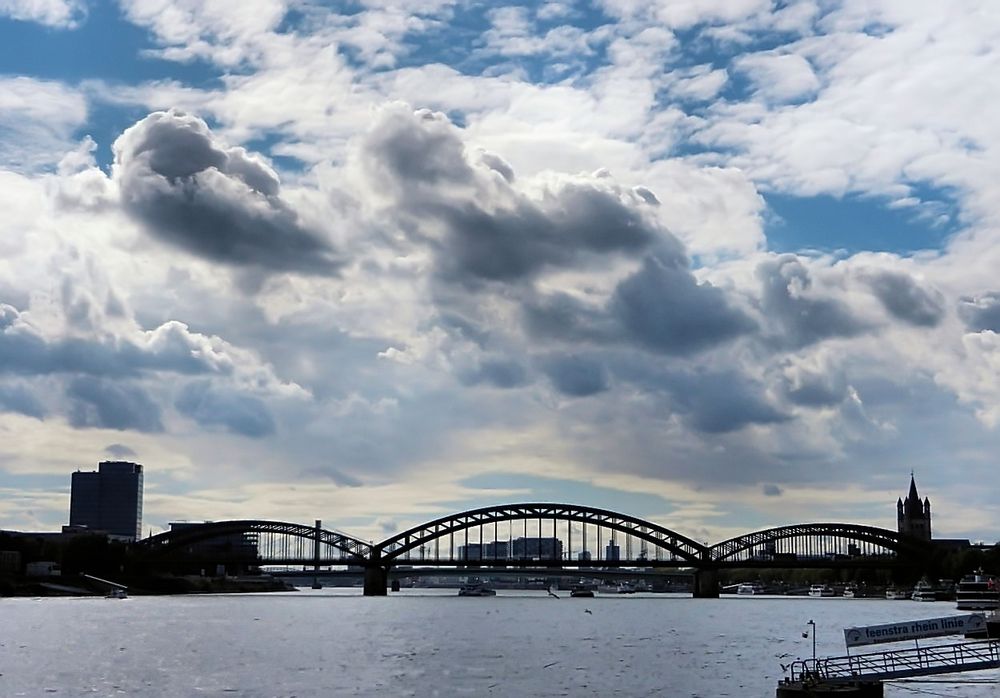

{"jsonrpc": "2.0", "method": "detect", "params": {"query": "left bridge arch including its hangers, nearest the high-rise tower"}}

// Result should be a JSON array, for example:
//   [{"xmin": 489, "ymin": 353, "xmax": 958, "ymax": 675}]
[{"xmin": 137, "ymin": 519, "xmax": 371, "ymax": 564}]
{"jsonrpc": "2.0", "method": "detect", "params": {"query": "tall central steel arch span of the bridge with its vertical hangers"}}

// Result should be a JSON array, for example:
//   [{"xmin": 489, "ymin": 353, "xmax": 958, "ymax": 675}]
[{"xmin": 373, "ymin": 503, "xmax": 708, "ymax": 564}]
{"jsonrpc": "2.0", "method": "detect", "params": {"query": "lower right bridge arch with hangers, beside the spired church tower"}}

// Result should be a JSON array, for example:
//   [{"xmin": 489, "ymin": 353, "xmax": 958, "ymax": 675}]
[{"xmin": 708, "ymin": 523, "xmax": 929, "ymax": 563}]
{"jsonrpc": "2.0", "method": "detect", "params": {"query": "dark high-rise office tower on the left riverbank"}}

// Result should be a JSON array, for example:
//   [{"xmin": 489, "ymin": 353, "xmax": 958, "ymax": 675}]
[{"xmin": 69, "ymin": 461, "xmax": 142, "ymax": 540}]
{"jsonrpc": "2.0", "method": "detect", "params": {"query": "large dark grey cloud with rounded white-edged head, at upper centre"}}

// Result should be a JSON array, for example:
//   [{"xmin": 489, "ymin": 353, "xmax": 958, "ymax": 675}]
[{"xmin": 362, "ymin": 109, "xmax": 660, "ymax": 286}]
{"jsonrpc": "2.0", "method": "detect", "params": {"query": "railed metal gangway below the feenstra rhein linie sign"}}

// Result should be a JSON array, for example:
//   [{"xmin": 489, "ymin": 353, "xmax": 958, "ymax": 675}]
[{"xmin": 791, "ymin": 640, "xmax": 1000, "ymax": 683}]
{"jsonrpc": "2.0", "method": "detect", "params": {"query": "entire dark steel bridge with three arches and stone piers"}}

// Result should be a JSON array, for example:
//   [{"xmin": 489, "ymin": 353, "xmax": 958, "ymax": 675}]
[{"xmin": 127, "ymin": 503, "xmax": 932, "ymax": 597}]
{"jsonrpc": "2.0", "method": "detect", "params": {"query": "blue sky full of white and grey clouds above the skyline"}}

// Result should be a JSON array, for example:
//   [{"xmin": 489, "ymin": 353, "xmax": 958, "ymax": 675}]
[{"xmin": 0, "ymin": 0, "xmax": 1000, "ymax": 542}]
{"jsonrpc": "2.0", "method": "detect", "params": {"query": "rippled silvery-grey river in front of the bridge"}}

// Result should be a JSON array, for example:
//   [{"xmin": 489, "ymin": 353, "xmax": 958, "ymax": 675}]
[{"xmin": 0, "ymin": 589, "xmax": 1000, "ymax": 698}]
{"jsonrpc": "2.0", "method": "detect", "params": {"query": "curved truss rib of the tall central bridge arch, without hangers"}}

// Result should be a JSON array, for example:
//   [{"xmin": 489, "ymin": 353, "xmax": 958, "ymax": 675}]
[{"xmin": 373, "ymin": 503, "xmax": 708, "ymax": 564}]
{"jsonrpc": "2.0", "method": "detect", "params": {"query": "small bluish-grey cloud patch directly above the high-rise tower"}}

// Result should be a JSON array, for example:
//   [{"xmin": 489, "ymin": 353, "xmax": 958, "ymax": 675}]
[{"xmin": 66, "ymin": 376, "xmax": 163, "ymax": 432}]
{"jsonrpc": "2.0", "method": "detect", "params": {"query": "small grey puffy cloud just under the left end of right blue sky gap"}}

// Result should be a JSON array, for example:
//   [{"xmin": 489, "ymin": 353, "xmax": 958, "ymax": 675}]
[{"xmin": 757, "ymin": 255, "xmax": 868, "ymax": 348}]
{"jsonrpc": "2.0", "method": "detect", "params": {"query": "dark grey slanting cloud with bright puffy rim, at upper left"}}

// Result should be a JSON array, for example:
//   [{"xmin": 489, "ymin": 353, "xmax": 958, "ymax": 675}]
[{"xmin": 114, "ymin": 111, "xmax": 339, "ymax": 274}]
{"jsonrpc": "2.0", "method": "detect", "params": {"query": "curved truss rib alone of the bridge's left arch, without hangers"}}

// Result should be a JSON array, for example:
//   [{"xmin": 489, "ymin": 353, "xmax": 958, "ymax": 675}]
[{"xmin": 136, "ymin": 519, "xmax": 371, "ymax": 563}]
